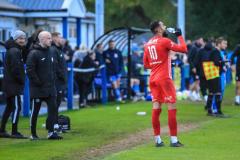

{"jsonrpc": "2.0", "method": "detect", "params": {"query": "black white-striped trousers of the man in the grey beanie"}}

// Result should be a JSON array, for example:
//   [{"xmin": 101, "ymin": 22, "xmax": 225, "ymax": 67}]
[{"xmin": 0, "ymin": 95, "xmax": 22, "ymax": 134}]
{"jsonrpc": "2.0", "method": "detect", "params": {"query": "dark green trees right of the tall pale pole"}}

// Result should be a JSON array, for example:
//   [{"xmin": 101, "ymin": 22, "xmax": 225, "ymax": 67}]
[{"xmin": 186, "ymin": 0, "xmax": 240, "ymax": 47}]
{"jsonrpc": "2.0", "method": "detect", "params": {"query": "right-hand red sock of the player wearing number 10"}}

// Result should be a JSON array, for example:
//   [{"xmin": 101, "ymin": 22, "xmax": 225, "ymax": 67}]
[{"xmin": 168, "ymin": 109, "xmax": 177, "ymax": 136}]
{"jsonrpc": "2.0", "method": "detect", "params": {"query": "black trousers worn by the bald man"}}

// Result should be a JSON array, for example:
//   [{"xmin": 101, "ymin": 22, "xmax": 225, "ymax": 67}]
[{"xmin": 30, "ymin": 96, "xmax": 57, "ymax": 135}]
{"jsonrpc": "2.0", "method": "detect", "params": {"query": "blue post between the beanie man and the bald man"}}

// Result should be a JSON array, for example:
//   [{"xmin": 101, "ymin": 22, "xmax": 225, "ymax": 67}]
[{"xmin": 23, "ymin": 76, "xmax": 30, "ymax": 117}]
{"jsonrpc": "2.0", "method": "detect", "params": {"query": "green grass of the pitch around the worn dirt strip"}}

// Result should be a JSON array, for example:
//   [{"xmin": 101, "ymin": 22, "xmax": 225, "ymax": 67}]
[{"xmin": 0, "ymin": 85, "xmax": 240, "ymax": 160}]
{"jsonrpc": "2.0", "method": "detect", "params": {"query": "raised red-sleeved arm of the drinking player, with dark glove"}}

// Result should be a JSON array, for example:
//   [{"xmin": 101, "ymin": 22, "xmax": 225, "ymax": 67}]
[{"xmin": 167, "ymin": 29, "xmax": 187, "ymax": 53}]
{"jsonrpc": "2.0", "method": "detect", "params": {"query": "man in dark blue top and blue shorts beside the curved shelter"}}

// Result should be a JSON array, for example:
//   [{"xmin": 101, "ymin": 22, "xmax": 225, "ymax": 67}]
[{"xmin": 103, "ymin": 40, "xmax": 123, "ymax": 102}]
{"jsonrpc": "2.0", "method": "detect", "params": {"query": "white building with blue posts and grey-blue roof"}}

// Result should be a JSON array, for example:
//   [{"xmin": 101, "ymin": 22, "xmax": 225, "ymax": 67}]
[{"xmin": 0, "ymin": 0, "xmax": 95, "ymax": 48}]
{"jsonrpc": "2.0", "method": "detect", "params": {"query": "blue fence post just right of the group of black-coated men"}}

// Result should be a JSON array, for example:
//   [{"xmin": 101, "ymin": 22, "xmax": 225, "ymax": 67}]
[{"xmin": 67, "ymin": 63, "xmax": 73, "ymax": 110}]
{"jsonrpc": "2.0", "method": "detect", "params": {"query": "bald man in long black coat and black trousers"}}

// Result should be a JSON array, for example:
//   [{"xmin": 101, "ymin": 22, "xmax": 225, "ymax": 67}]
[{"xmin": 27, "ymin": 31, "xmax": 62, "ymax": 140}]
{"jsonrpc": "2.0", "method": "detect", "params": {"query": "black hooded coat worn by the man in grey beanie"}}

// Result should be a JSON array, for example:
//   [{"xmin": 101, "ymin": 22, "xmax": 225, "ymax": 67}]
[{"xmin": 3, "ymin": 38, "xmax": 25, "ymax": 97}]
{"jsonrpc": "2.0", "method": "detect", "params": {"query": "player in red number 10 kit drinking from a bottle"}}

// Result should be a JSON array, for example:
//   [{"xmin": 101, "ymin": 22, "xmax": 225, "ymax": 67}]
[{"xmin": 143, "ymin": 21, "xmax": 187, "ymax": 147}]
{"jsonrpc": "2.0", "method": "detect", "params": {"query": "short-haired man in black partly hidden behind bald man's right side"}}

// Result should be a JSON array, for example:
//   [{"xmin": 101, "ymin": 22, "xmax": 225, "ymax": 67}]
[{"xmin": 52, "ymin": 32, "xmax": 67, "ymax": 131}]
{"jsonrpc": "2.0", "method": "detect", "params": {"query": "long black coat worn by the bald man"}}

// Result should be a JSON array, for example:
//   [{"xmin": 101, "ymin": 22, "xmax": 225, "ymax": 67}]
[{"xmin": 26, "ymin": 43, "xmax": 56, "ymax": 98}]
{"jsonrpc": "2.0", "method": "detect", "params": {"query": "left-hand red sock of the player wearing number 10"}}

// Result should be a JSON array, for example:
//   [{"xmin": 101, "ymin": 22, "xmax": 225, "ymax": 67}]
[{"xmin": 152, "ymin": 108, "xmax": 162, "ymax": 136}]
